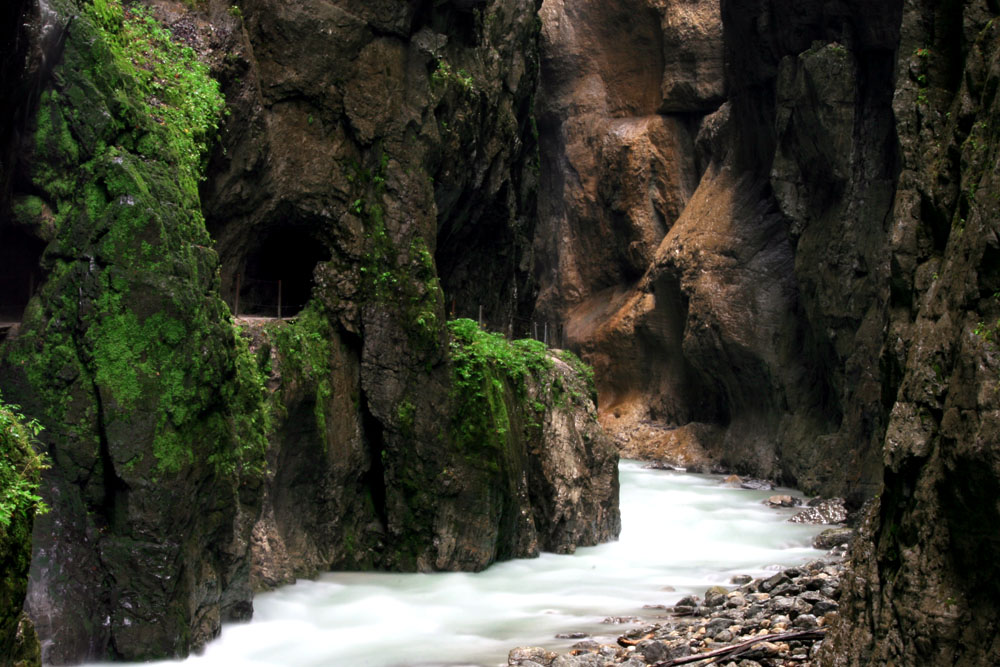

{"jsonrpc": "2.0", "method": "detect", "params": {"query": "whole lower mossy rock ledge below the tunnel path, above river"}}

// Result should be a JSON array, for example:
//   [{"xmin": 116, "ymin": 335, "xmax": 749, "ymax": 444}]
[{"xmin": 246, "ymin": 314, "xmax": 620, "ymax": 588}]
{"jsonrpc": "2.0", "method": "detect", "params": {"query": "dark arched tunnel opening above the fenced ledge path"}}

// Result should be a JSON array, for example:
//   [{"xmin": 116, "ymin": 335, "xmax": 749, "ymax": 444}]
[{"xmin": 231, "ymin": 227, "xmax": 330, "ymax": 318}]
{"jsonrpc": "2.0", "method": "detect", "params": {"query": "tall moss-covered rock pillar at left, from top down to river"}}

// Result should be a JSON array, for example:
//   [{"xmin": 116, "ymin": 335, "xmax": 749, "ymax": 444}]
[{"xmin": 0, "ymin": 0, "xmax": 266, "ymax": 663}]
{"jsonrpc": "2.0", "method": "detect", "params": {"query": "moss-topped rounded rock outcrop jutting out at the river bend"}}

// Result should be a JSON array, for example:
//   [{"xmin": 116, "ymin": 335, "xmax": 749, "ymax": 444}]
[{"xmin": 376, "ymin": 320, "xmax": 620, "ymax": 570}]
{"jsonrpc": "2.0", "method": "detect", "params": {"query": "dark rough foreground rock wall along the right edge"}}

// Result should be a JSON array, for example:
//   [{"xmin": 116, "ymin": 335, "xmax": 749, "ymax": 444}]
[{"xmin": 823, "ymin": 2, "xmax": 1000, "ymax": 665}]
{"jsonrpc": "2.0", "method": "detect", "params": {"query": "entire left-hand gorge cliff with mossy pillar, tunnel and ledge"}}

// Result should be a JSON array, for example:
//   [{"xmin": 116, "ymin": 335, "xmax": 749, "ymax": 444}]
[{"xmin": 0, "ymin": 0, "xmax": 619, "ymax": 664}]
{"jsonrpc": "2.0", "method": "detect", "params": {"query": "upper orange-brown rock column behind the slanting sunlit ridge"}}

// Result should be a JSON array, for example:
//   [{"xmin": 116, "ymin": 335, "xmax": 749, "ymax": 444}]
[{"xmin": 536, "ymin": 0, "xmax": 722, "ymax": 314}]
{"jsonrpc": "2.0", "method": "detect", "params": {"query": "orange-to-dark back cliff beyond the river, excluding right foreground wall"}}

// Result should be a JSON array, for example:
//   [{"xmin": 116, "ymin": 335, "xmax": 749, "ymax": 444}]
[{"xmin": 538, "ymin": 1, "xmax": 899, "ymax": 499}]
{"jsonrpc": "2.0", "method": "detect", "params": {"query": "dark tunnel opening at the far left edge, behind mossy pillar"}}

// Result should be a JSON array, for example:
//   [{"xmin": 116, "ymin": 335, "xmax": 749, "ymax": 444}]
[{"xmin": 0, "ymin": 226, "xmax": 45, "ymax": 340}]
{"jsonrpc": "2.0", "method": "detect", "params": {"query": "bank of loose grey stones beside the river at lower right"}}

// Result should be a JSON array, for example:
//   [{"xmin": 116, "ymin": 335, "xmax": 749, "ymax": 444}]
[{"xmin": 507, "ymin": 556, "xmax": 843, "ymax": 667}]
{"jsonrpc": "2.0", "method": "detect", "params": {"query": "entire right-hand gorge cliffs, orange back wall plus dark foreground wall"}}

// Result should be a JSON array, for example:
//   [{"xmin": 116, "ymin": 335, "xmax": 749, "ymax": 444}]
[{"xmin": 538, "ymin": 0, "xmax": 1000, "ymax": 665}]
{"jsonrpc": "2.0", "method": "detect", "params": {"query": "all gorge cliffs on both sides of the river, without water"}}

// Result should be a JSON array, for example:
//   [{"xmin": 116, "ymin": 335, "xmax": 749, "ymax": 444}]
[{"xmin": 0, "ymin": 0, "xmax": 1000, "ymax": 665}]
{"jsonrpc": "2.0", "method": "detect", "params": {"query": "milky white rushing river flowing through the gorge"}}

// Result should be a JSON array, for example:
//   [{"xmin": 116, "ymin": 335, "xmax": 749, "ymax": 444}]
[{"xmin": 94, "ymin": 462, "xmax": 822, "ymax": 667}]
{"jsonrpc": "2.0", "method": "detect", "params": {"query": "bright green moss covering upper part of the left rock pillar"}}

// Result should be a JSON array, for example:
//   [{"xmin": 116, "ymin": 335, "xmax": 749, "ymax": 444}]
[{"xmin": 4, "ymin": 0, "xmax": 267, "ymax": 480}]
